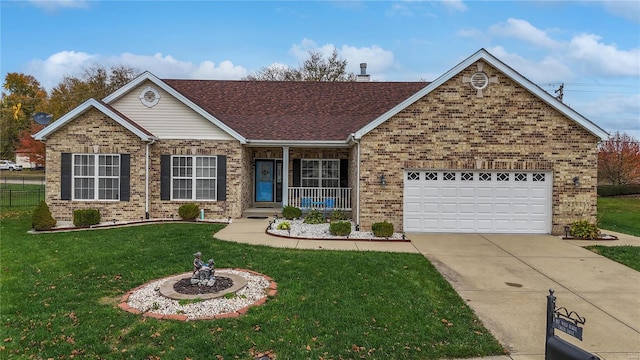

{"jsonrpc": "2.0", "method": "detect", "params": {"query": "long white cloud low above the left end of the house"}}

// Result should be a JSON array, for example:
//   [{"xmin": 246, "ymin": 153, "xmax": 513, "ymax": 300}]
[{"xmin": 27, "ymin": 51, "xmax": 248, "ymax": 90}]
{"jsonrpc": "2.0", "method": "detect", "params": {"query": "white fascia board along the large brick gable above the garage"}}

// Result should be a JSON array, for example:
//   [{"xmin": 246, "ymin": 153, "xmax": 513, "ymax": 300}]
[{"xmin": 353, "ymin": 49, "xmax": 609, "ymax": 140}]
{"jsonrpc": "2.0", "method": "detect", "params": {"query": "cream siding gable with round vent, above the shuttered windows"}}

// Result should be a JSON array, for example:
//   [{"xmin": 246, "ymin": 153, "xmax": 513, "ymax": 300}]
[{"xmin": 110, "ymin": 81, "xmax": 234, "ymax": 140}]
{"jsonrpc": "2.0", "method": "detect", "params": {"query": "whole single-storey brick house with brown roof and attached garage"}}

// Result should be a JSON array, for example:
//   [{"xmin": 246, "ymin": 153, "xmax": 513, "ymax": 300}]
[{"xmin": 34, "ymin": 49, "xmax": 607, "ymax": 234}]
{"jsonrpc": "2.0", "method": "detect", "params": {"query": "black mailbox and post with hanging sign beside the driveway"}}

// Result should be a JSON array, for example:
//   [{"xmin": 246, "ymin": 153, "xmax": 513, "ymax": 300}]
[{"xmin": 544, "ymin": 289, "xmax": 600, "ymax": 360}]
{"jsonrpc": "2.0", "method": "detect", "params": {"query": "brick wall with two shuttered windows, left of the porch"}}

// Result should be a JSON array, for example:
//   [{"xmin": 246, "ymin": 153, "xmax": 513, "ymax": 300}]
[{"xmin": 46, "ymin": 109, "xmax": 248, "ymax": 221}]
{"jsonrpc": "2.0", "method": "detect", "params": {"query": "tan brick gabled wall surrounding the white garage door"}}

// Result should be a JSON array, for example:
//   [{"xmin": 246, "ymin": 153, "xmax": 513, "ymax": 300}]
[{"xmin": 359, "ymin": 64, "xmax": 598, "ymax": 234}]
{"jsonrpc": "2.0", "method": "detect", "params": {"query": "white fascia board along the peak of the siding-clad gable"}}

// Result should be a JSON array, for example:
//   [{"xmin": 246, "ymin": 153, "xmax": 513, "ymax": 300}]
[{"xmin": 102, "ymin": 71, "xmax": 247, "ymax": 144}]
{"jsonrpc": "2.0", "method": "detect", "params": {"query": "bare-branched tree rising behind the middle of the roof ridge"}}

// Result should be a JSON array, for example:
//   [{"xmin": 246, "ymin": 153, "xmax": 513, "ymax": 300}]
[{"xmin": 244, "ymin": 49, "xmax": 356, "ymax": 81}]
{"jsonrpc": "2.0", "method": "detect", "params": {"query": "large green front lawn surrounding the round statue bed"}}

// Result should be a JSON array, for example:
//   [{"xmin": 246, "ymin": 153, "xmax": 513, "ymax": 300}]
[{"xmin": 0, "ymin": 210, "xmax": 504, "ymax": 359}]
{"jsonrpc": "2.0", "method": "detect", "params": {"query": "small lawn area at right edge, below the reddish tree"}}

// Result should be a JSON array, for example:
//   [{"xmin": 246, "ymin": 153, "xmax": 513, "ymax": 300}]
[{"xmin": 598, "ymin": 197, "xmax": 640, "ymax": 236}]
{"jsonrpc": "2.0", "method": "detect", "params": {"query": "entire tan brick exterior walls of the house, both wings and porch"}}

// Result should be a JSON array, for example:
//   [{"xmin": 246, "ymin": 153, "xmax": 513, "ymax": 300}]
[{"xmin": 46, "ymin": 64, "xmax": 599, "ymax": 234}]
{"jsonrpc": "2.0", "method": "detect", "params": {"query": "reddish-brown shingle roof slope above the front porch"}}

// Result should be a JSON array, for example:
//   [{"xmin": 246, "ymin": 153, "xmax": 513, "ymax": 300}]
[{"xmin": 163, "ymin": 80, "xmax": 427, "ymax": 141}]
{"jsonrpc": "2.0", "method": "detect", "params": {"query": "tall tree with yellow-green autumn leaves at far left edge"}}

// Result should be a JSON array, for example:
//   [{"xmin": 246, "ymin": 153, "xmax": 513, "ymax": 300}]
[{"xmin": 0, "ymin": 73, "xmax": 47, "ymax": 159}]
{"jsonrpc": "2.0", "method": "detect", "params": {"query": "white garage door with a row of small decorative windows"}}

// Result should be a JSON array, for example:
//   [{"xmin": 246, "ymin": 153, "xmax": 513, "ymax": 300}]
[{"xmin": 404, "ymin": 170, "xmax": 553, "ymax": 234}]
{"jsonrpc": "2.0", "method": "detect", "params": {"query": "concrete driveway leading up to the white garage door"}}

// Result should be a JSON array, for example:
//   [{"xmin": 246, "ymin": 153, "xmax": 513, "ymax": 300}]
[{"xmin": 407, "ymin": 234, "xmax": 640, "ymax": 360}]
